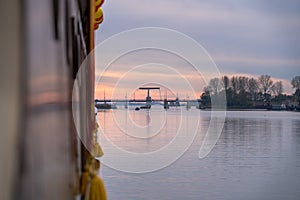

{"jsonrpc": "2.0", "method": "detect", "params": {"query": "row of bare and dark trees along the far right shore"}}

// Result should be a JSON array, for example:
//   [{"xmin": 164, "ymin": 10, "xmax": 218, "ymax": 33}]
[{"xmin": 201, "ymin": 75, "xmax": 300, "ymax": 109}]
